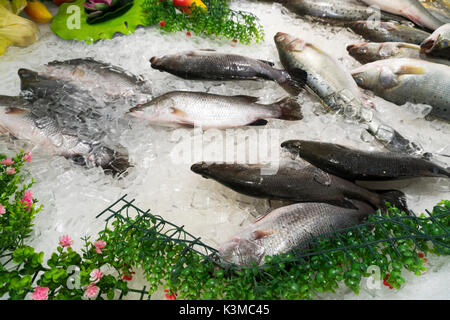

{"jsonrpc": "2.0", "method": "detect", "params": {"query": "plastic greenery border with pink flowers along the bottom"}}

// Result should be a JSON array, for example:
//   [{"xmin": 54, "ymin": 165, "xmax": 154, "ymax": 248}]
[{"xmin": 0, "ymin": 152, "xmax": 450, "ymax": 299}]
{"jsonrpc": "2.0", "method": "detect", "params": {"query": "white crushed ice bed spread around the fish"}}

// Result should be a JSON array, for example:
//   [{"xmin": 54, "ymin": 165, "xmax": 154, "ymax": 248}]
[{"xmin": 0, "ymin": 1, "xmax": 450, "ymax": 299}]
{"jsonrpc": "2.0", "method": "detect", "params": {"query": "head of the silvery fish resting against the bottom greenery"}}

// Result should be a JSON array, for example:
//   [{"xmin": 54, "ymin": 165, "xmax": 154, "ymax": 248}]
[{"xmin": 219, "ymin": 237, "xmax": 265, "ymax": 266}]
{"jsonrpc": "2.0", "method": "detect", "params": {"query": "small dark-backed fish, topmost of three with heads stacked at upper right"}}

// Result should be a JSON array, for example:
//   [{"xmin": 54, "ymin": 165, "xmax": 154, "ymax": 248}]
[{"xmin": 346, "ymin": 21, "xmax": 430, "ymax": 44}]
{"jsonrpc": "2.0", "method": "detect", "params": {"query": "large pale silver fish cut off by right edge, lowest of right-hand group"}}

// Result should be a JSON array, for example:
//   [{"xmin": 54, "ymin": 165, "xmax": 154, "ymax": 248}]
[{"xmin": 352, "ymin": 58, "xmax": 450, "ymax": 120}]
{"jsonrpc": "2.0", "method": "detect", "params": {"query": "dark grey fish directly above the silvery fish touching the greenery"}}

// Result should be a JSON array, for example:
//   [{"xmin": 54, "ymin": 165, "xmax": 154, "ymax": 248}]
[{"xmin": 191, "ymin": 161, "xmax": 405, "ymax": 209}]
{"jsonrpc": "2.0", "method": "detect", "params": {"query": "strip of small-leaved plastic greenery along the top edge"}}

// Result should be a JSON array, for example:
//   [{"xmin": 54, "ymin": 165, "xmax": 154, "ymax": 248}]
[{"xmin": 143, "ymin": 0, "xmax": 264, "ymax": 44}]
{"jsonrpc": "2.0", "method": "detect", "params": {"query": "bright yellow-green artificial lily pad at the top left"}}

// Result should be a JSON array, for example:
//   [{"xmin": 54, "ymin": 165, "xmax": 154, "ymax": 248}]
[{"xmin": 50, "ymin": 0, "xmax": 145, "ymax": 43}]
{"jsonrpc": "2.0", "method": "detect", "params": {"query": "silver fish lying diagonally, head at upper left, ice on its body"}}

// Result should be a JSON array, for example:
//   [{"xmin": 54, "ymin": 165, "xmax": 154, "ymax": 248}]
[{"xmin": 275, "ymin": 32, "xmax": 421, "ymax": 153}]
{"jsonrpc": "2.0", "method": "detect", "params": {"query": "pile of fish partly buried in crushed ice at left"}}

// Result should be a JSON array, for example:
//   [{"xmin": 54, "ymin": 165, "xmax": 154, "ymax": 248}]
[{"xmin": 0, "ymin": 58, "xmax": 151, "ymax": 175}]
